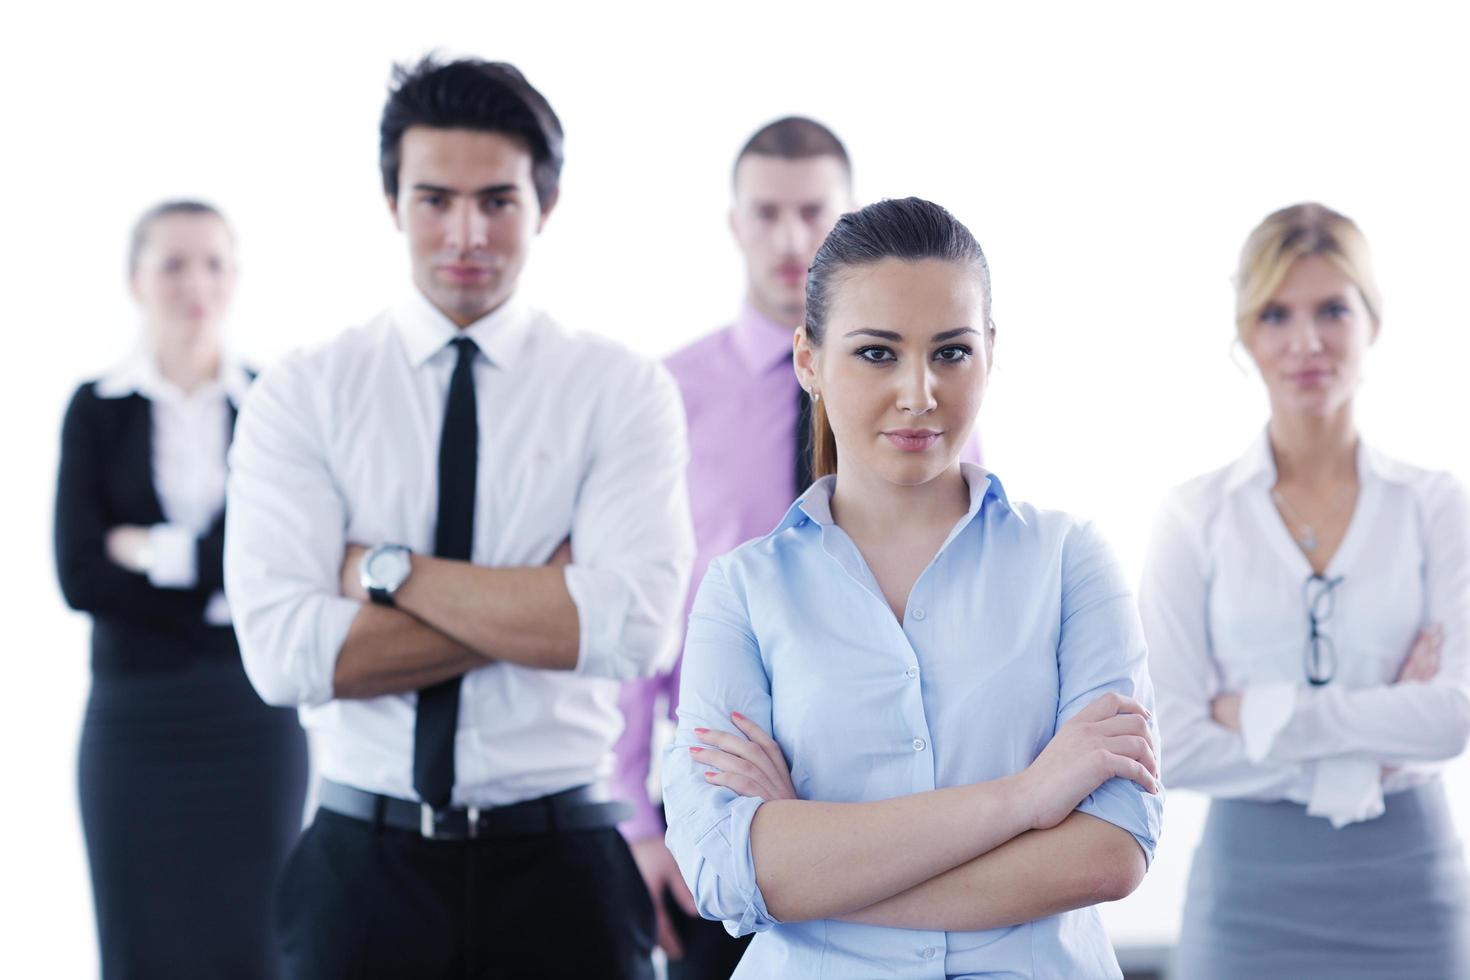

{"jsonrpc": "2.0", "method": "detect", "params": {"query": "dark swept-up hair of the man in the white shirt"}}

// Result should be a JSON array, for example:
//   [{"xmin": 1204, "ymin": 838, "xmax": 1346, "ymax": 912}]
[{"xmin": 378, "ymin": 54, "xmax": 562, "ymax": 209}]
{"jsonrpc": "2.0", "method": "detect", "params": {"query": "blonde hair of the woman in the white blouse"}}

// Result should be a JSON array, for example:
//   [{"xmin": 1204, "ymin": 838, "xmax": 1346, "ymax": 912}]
[{"xmin": 1235, "ymin": 203, "xmax": 1383, "ymax": 342}]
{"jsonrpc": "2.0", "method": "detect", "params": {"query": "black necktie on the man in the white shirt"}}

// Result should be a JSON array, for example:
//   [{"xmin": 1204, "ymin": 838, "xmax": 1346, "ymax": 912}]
[{"xmin": 413, "ymin": 336, "xmax": 479, "ymax": 810}]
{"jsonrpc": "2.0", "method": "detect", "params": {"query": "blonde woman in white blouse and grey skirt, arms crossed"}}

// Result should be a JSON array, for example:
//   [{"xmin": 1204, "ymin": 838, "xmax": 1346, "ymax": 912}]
[{"xmin": 1141, "ymin": 204, "xmax": 1470, "ymax": 980}]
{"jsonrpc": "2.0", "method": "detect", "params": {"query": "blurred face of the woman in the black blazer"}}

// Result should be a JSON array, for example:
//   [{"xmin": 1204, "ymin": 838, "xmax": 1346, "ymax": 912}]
[{"xmin": 132, "ymin": 215, "xmax": 235, "ymax": 344}]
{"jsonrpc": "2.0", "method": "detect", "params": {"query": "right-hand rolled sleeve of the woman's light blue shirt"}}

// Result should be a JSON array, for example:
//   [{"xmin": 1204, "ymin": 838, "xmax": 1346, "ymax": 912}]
[{"xmin": 1057, "ymin": 525, "xmax": 1164, "ymax": 864}]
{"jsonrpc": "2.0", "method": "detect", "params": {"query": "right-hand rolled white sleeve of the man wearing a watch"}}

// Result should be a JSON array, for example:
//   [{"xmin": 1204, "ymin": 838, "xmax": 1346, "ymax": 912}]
[{"xmin": 564, "ymin": 361, "xmax": 694, "ymax": 680}]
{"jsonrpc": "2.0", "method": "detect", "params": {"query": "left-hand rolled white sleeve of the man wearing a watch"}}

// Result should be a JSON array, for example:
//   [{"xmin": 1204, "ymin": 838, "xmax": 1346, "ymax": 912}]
[{"xmin": 225, "ymin": 361, "xmax": 362, "ymax": 707}]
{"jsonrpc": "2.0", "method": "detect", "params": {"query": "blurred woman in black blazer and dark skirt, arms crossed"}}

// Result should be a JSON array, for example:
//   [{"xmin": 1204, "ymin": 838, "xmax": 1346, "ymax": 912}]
[{"xmin": 56, "ymin": 201, "xmax": 306, "ymax": 980}]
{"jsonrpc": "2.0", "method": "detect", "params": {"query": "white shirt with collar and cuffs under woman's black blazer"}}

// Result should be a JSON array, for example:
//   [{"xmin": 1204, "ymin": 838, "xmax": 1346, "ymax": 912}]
[{"xmin": 96, "ymin": 350, "xmax": 250, "ymax": 626}]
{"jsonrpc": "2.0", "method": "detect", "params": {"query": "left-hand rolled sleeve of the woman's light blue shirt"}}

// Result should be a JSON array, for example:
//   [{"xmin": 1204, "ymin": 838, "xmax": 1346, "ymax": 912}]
[{"xmin": 663, "ymin": 560, "xmax": 779, "ymax": 936}]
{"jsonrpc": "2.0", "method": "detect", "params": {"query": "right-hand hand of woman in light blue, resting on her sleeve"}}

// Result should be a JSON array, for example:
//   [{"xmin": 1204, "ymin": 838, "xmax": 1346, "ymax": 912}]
[{"xmin": 1016, "ymin": 693, "xmax": 1160, "ymax": 830}]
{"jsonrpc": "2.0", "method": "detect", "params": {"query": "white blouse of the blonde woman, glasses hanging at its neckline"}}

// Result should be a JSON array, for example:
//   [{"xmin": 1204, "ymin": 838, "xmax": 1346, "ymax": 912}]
[{"xmin": 1139, "ymin": 433, "xmax": 1470, "ymax": 827}]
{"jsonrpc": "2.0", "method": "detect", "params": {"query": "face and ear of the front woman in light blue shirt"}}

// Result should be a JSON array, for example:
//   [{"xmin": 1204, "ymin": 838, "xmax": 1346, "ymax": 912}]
[{"xmin": 797, "ymin": 259, "xmax": 991, "ymax": 486}]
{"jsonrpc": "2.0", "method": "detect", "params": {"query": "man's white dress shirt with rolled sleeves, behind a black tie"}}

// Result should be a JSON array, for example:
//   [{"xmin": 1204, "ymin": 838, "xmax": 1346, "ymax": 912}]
[{"xmin": 225, "ymin": 291, "xmax": 694, "ymax": 805}]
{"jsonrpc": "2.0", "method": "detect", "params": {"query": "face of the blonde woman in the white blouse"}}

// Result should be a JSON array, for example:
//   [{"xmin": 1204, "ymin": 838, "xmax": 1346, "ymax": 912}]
[{"xmin": 1245, "ymin": 256, "xmax": 1377, "ymax": 417}]
